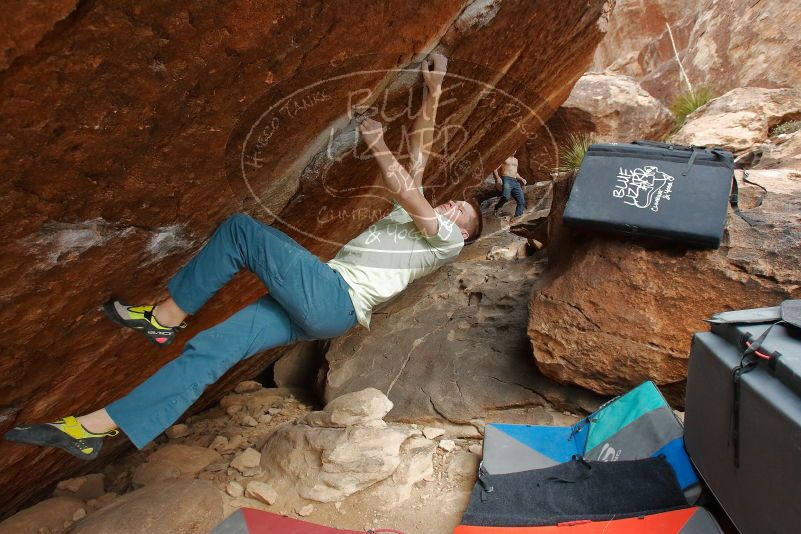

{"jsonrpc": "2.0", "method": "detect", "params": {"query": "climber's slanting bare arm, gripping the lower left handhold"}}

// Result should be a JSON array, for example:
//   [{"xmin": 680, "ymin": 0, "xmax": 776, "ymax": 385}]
[{"xmin": 359, "ymin": 119, "xmax": 439, "ymax": 236}]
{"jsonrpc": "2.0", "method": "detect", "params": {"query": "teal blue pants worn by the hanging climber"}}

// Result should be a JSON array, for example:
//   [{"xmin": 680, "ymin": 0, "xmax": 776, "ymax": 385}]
[{"xmin": 106, "ymin": 214, "xmax": 357, "ymax": 449}]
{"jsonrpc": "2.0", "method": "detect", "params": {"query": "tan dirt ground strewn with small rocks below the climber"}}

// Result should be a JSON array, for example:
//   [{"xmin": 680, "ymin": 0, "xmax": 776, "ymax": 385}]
[{"xmin": 12, "ymin": 388, "xmax": 579, "ymax": 534}]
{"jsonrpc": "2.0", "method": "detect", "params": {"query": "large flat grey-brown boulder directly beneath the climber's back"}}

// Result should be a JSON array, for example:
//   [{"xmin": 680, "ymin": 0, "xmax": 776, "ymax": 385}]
[{"xmin": 323, "ymin": 207, "xmax": 600, "ymax": 426}]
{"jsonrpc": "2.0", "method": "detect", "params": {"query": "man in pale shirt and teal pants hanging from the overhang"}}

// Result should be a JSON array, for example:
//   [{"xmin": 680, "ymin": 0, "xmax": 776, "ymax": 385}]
[{"xmin": 5, "ymin": 54, "xmax": 481, "ymax": 460}]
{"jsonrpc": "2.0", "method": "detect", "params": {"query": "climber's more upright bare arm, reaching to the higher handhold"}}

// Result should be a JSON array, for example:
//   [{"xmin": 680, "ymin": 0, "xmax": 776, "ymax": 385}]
[{"xmin": 409, "ymin": 53, "xmax": 448, "ymax": 187}]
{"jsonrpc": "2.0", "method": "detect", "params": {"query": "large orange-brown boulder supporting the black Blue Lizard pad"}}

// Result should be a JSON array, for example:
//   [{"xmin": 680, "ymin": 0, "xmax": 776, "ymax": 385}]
[{"xmin": 528, "ymin": 107, "xmax": 801, "ymax": 405}]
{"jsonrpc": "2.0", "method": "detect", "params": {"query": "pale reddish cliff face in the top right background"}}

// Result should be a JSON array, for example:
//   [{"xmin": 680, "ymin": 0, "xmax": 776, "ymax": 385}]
[{"xmin": 594, "ymin": 0, "xmax": 801, "ymax": 101}]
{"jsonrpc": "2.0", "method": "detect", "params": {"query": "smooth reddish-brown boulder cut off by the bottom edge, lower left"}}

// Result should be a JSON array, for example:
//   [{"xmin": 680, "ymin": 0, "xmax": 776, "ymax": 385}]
[{"xmin": 72, "ymin": 480, "xmax": 223, "ymax": 534}]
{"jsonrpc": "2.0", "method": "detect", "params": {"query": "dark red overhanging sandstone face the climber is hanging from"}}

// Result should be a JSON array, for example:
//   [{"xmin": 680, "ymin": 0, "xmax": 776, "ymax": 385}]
[{"xmin": 0, "ymin": 0, "xmax": 609, "ymax": 516}]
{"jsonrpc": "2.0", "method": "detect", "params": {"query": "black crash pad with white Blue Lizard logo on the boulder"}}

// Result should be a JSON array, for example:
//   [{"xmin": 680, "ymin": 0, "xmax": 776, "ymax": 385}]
[{"xmin": 564, "ymin": 141, "xmax": 736, "ymax": 248}]
